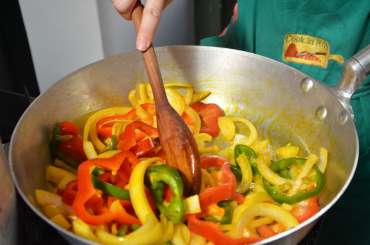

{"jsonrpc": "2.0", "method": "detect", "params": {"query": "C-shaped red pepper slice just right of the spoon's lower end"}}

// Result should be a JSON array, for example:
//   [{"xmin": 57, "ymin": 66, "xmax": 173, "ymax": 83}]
[{"xmin": 199, "ymin": 156, "xmax": 236, "ymax": 210}]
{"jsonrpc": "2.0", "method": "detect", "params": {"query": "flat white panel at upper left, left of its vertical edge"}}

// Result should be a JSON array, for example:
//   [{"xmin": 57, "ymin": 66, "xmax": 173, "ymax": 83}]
[{"xmin": 19, "ymin": 0, "xmax": 104, "ymax": 91}]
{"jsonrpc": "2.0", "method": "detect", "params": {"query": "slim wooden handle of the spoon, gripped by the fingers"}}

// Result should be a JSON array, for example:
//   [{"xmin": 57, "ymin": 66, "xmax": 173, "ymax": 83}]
[{"xmin": 132, "ymin": 3, "xmax": 168, "ymax": 107}]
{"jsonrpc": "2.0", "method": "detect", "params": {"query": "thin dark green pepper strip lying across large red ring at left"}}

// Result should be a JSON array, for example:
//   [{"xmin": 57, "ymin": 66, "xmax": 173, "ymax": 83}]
[{"xmin": 91, "ymin": 168, "xmax": 130, "ymax": 200}]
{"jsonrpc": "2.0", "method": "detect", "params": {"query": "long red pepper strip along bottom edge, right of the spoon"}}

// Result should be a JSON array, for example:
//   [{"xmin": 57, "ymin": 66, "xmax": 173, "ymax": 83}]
[{"xmin": 187, "ymin": 214, "xmax": 261, "ymax": 245}]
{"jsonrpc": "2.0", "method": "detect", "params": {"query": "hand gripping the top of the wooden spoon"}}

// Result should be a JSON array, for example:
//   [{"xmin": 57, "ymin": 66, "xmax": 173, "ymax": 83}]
[{"xmin": 112, "ymin": 0, "xmax": 171, "ymax": 51}]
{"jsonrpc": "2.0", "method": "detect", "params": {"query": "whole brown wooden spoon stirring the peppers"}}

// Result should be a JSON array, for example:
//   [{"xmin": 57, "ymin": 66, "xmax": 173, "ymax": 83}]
[{"xmin": 132, "ymin": 4, "xmax": 201, "ymax": 194}]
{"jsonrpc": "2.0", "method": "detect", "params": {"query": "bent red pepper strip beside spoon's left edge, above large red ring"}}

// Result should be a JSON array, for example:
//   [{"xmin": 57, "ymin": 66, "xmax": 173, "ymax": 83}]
[{"xmin": 118, "ymin": 121, "xmax": 158, "ymax": 151}]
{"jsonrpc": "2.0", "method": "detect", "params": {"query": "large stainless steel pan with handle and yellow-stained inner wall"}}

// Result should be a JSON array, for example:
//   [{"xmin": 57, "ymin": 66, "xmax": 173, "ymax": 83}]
[{"xmin": 10, "ymin": 46, "xmax": 370, "ymax": 244}]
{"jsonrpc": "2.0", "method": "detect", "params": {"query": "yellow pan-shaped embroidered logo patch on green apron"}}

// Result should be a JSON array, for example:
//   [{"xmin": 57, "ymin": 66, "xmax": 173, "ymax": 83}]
[{"xmin": 283, "ymin": 34, "xmax": 344, "ymax": 68}]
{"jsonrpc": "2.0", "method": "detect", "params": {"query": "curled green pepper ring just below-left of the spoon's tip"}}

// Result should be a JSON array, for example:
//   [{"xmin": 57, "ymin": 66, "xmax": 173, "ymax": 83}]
[{"xmin": 147, "ymin": 164, "xmax": 185, "ymax": 224}]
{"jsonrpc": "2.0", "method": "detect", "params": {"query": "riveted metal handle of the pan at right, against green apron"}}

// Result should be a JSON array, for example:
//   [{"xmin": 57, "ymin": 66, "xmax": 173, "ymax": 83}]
[{"xmin": 335, "ymin": 45, "xmax": 370, "ymax": 113}]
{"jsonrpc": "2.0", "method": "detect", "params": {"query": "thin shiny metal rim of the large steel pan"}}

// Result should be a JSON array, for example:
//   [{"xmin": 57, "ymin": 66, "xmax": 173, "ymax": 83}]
[{"xmin": 9, "ymin": 45, "xmax": 359, "ymax": 244}]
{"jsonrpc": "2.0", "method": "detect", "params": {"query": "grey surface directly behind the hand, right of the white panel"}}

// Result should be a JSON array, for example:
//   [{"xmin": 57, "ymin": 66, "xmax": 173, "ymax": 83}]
[{"xmin": 98, "ymin": 0, "xmax": 194, "ymax": 56}]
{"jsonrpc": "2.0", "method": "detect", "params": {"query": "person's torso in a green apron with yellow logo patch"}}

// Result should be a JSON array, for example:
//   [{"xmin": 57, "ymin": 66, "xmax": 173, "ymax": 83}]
[{"xmin": 203, "ymin": 0, "xmax": 370, "ymax": 155}]
